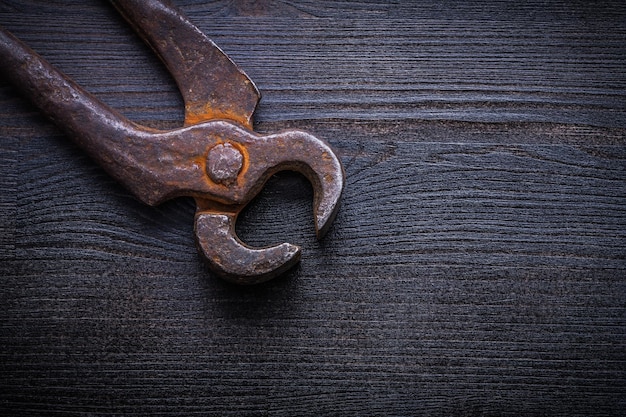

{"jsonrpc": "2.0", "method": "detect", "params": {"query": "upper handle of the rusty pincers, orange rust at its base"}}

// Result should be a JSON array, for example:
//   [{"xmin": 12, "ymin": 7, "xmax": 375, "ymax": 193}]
[{"xmin": 111, "ymin": 0, "xmax": 261, "ymax": 129}]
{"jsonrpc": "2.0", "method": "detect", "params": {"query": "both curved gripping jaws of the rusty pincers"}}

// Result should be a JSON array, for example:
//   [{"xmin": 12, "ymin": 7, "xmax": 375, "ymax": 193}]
[{"xmin": 195, "ymin": 127, "xmax": 345, "ymax": 285}]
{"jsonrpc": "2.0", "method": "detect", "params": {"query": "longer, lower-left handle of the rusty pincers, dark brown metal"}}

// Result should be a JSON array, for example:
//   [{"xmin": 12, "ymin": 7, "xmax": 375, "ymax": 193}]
[{"xmin": 0, "ymin": 27, "xmax": 190, "ymax": 205}]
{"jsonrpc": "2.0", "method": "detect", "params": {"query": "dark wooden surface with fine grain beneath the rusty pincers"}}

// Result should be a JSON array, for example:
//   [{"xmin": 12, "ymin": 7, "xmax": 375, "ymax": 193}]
[{"xmin": 0, "ymin": 0, "xmax": 626, "ymax": 416}]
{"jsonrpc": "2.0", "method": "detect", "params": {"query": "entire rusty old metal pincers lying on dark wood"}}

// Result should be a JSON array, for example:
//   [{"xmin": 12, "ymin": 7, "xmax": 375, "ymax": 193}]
[{"xmin": 0, "ymin": 0, "xmax": 345, "ymax": 284}]
